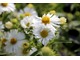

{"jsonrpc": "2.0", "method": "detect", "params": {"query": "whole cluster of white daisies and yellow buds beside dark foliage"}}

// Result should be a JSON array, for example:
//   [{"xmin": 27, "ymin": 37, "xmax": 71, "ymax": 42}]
[{"xmin": 0, "ymin": 3, "xmax": 66, "ymax": 55}]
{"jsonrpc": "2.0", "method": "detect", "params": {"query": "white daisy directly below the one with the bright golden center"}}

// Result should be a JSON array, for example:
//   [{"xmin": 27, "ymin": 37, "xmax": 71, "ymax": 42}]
[{"xmin": 33, "ymin": 24, "xmax": 56, "ymax": 45}]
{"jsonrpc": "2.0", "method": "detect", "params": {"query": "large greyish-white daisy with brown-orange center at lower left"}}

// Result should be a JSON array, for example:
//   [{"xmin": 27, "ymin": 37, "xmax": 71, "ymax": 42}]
[{"xmin": 4, "ymin": 30, "xmax": 25, "ymax": 55}]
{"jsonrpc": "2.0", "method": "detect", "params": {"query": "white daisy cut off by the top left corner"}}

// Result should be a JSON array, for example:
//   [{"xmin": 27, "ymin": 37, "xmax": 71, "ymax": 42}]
[{"xmin": 0, "ymin": 3, "xmax": 15, "ymax": 14}]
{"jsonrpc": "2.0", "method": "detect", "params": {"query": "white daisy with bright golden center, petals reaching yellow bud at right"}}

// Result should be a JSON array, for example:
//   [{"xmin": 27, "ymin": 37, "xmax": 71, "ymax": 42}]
[{"xmin": 36, "ymin": 13, "xmax": 66, "ymax": 27}]
